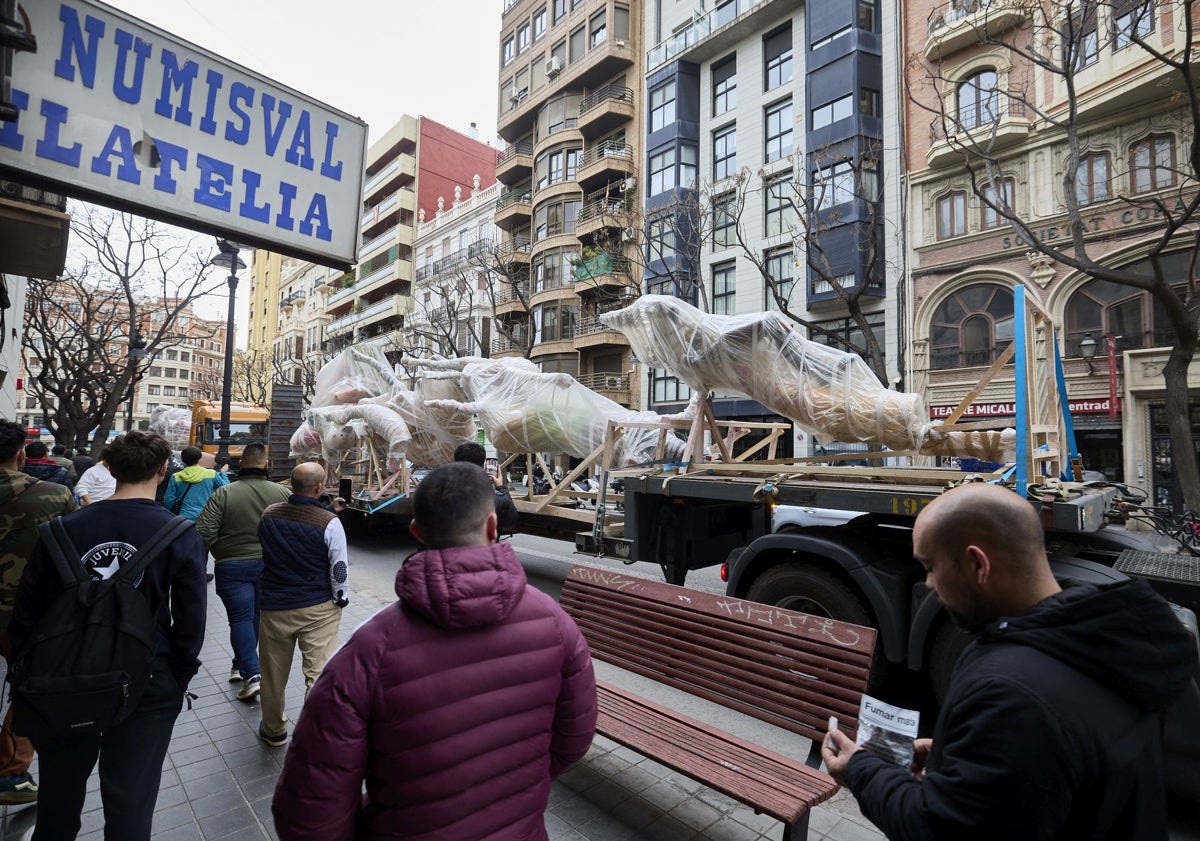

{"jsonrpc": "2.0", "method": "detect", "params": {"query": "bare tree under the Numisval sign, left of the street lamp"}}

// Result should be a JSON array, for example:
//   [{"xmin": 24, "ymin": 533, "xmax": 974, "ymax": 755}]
[{"xmin": 24, "ymin": 205, "xmax": 223, "ymax": 450}]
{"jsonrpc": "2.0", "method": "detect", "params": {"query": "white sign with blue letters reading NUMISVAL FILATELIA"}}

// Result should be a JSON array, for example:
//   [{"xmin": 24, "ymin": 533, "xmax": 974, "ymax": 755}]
[{"xmin": 0, "ymin": 0, "xmax": 367, "ymax": 268}]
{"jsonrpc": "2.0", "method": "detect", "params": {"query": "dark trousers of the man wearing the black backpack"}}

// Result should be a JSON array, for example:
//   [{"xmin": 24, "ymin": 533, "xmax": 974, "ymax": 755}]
[{"xmin": 34, "ymin": 661, "xmax": 184, "ymax": 841}]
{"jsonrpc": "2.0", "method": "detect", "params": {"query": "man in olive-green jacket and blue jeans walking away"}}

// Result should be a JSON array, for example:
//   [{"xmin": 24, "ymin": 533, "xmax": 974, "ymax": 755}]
[{"xmin": 196, "ymin": 444, "xmax": 290, "ymax": 701}]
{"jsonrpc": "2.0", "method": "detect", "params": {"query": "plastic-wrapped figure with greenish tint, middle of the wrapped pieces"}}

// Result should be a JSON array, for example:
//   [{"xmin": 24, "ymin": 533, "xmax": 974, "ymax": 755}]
[{"xmin": 421, "ymin": 358, "xmax": 682, "ymax": 465}]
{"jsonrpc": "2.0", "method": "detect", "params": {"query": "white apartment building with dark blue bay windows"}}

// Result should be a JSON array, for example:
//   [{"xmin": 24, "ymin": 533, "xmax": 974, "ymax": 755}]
[{"xmin": 644, "ymin": 0, "xmax": 902, "ymax": 449}]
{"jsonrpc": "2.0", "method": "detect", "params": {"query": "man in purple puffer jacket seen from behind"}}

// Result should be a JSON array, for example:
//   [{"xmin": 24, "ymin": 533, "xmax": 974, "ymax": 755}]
[{"xmin": 271, "ymin": 463, "xmax": 596, "ymax": 841}]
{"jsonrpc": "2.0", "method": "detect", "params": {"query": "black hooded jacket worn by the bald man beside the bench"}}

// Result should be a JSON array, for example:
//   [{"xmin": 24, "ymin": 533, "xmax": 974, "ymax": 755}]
[{"xmin": 846, "ymin": 581, "xmax": 1196, "ymax": 841}]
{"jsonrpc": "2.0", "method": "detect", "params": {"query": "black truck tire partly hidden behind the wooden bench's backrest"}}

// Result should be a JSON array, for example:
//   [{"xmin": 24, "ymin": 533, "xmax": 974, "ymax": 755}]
[{"xmin": 746, "ymin": 564, "xmax": 887, "ymax": 693}]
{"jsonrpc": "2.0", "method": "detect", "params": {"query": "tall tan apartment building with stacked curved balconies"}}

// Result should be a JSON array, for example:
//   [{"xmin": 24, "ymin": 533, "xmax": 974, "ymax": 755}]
[{"xmin": 492, "ymin": 0, "xmax": 643, "ymax": 406}]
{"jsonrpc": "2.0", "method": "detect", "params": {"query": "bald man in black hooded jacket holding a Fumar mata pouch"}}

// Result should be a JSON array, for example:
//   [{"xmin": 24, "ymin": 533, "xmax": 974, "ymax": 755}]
[{"xmin": 821, "ymin": 485, "xmax": 1196, "ymax": 841}]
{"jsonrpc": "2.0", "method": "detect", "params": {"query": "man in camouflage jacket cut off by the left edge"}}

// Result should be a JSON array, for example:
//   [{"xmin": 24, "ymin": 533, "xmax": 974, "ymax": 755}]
[{"xmin": 0, "ymin": 420, "xmax": 74, "ymax": 806}]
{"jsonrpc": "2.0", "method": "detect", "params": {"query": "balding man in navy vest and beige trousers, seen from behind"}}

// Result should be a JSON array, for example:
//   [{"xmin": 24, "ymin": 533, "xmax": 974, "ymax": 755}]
[{"xmin": 258, "ymin": 462, "xmax": 350, "ymax": 747}]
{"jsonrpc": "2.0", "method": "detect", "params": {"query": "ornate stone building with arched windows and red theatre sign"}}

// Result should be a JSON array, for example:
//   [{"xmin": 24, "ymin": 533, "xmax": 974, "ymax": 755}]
[{"xmin": 905, "ymin": 0, "xmax": 1200, "ymax": 505}]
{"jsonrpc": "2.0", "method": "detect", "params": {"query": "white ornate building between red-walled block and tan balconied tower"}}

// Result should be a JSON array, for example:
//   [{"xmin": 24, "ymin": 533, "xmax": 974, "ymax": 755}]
[{"xmin": 415, "ymin": 175, "xmax": 506, "ymax": 358}]
